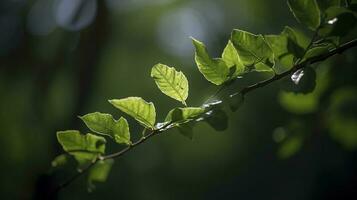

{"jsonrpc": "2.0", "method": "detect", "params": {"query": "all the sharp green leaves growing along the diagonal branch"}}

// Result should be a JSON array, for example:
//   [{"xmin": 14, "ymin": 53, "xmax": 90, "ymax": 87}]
[{"xmin": 53, "ymin": 0, "xmax": 357, "ymax": 191}]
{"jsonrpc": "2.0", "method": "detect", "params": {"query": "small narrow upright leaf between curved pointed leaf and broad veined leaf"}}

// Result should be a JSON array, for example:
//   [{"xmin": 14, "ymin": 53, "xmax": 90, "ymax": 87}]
[{"xmin": 222, "ymin": 40, "xmax": 245, "ymax": 77}]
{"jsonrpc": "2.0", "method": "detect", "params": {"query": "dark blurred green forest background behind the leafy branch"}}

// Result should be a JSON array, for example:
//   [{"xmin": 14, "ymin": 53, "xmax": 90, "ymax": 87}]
[{"xmin": 0, "ymin": 0, "xmax": 357, "ymax": 200}]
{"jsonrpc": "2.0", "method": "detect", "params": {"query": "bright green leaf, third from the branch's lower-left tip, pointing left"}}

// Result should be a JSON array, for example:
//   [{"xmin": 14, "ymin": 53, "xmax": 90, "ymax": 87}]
[{"xmin": 109, "ymin": 97, "xmax": 156, "ymax": 129}]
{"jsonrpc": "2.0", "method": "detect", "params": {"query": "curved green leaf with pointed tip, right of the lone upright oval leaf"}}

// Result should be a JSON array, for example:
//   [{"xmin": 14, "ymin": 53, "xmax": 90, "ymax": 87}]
[{"xmin": 192, "ymin": 38, "xmax": 229, "ymax": 85}]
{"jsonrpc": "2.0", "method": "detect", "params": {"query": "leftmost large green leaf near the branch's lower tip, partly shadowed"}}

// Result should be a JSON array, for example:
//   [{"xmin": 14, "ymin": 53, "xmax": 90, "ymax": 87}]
[{"xmin": 57, "ymin": 130, "xmax": 106, "ymax": 167}]
